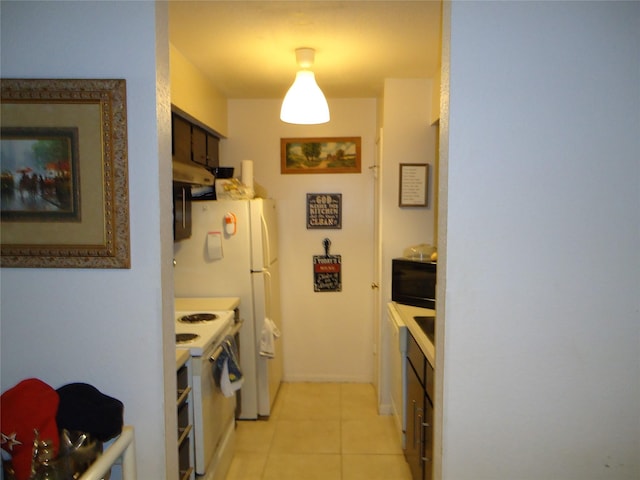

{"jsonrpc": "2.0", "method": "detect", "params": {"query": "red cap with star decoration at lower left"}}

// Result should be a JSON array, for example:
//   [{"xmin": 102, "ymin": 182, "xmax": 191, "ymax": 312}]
[{"xmin": 0, "ymin": 378, "xmax": 60, "ymax": 480}]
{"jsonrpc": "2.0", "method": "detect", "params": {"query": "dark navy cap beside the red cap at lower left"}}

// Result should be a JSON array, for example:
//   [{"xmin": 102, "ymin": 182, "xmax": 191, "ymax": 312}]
[{"xmin": 56, "ymin": 383, "xmax": 124, "ymax": 442}]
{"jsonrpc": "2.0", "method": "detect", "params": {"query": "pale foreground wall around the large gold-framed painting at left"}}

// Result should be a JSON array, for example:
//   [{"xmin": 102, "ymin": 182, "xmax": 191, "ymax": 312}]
[{"xmin": 1, "ymin": 1, "xmax": 177, "ymax": 479}]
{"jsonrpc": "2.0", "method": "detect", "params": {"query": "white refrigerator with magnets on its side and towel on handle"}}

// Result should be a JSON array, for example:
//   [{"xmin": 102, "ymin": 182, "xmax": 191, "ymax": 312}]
[{"xmin": 174, "ymin": 199, "xmax": 283, "ymax": 419}]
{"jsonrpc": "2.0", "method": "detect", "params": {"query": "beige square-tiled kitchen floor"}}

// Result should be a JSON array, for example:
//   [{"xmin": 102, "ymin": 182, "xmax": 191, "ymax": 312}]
[{"xmin": 227, "ymin": 383, "xmax": 411, "ymax": 480}]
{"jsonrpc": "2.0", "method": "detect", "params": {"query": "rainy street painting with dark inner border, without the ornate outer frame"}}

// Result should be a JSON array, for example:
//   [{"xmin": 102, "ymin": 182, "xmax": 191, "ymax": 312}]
[{"xmin": 0, "ymin": 127, "xmax": 80, "ymax": 222}]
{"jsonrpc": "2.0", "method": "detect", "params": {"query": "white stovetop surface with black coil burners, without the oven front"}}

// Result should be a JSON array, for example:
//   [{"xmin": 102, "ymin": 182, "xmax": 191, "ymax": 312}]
[{"xmin": 175, "ymin": 310, "xmax": 234, "ymax": 357}]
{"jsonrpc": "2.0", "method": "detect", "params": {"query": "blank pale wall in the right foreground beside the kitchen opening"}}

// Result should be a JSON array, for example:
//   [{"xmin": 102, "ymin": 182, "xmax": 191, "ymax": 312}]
[{"xmin": 439, "ymin": 2, "xmax": 640, "ymax": 480}]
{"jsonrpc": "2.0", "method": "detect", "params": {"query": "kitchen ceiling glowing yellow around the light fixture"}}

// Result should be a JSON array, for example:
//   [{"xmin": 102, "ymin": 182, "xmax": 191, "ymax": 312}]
[{"xmin": 169, "ymin": 0, "xmax": 441, "ymax": 99}]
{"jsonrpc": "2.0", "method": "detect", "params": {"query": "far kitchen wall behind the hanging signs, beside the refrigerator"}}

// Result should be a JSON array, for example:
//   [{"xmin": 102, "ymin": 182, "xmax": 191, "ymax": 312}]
[{"xmin": 221, "ymin": 99, "xmax": 376, "ymax": 382}]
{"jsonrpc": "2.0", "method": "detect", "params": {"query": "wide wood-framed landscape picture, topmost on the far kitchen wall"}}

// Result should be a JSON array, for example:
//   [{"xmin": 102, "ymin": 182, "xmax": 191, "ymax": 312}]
[{"xmin": 280, "ymin": 137, "xmax": 360, "ymax": 173}]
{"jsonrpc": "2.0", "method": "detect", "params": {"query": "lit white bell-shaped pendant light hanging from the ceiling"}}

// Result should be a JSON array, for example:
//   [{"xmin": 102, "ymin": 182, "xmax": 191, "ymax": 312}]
[{"xmin": 280, "ymin": 48, "xmax": 330, "ymax": 125}]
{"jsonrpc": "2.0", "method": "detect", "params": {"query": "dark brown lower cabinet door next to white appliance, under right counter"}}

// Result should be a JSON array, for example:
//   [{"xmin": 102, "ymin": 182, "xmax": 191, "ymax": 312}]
[{"xmin": 404, "ymin": 359, "xmax": 424, "ymax": 480}]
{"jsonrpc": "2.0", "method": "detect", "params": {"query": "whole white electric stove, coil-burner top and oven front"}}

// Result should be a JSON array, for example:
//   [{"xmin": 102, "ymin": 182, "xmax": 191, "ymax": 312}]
[{"xmin": 175, "ymin": 304, "xmax": 239, "ymax": 480}]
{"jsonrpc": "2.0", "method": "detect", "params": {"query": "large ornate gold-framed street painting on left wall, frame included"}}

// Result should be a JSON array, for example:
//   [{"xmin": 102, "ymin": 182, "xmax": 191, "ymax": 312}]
[{"xmin": 0, "ymin": 79, "xmax": 131, "ymax": 268}]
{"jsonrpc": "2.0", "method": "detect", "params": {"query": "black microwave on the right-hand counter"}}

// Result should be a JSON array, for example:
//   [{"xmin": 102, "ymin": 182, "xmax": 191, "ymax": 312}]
[{"xmin": 391, "ymin": 258, "xmax": 437, "ymax": 309}]
